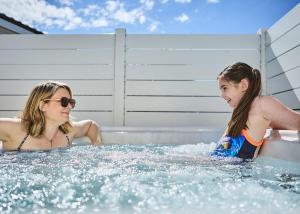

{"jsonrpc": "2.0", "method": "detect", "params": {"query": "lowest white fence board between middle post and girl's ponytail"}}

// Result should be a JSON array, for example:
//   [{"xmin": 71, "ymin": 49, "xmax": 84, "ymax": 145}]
[{"xmin": 125, "ymin": 112, "xmax": 231, "ymax": 129}]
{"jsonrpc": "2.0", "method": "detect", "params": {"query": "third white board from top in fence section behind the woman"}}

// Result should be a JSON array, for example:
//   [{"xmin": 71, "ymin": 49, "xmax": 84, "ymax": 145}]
[{"xmin": 0, "ymin": 64, "xmax": 113, "ymax": 80}]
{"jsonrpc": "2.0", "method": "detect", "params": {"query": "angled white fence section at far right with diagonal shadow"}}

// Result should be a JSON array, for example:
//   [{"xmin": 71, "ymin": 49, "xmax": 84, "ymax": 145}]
[{"xmin": 266, "ymin": 4, "xmax": 300, "ymax": 111}]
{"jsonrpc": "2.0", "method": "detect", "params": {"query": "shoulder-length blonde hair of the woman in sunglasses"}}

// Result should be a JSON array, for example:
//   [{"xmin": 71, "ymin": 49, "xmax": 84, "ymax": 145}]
[{"xmin": 21, "ymin": 81, "xmax": 72, "ymax": 137}]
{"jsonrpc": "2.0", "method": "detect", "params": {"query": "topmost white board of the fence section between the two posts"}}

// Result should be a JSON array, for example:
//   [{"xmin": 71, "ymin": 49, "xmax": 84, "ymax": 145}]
[{"xmin": 126, "ymin": 35, "xmax": 259, "ymax": 50}]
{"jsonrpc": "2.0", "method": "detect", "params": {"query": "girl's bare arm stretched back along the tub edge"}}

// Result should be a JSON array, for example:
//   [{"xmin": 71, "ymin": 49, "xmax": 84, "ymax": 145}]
[{"xmin": 261, "ymin": 96, "xmax": 300, "ymax": 130}]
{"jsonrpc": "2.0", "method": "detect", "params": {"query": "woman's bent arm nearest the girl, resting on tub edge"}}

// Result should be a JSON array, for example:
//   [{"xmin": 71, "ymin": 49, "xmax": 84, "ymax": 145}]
[{"xmin": 73, "ymin": 120, "xmax": 102, "ymax": 146}]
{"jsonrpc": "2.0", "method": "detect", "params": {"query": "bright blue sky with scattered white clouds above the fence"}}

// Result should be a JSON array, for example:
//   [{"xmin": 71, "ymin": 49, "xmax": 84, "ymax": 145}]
[{"xmin": 0, "ymin": 0, "xmax": 300, "ymax": 34}]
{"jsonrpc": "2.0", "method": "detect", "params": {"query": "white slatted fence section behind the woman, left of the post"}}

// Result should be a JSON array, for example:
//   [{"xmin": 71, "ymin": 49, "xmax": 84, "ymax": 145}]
[{"xmin": 0, "ymin": 35, "xmax": 115, "ymax": 125}]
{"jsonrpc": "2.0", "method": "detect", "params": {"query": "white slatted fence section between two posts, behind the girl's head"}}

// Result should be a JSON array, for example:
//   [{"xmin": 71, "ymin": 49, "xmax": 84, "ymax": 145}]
[{"xmin": 125, "ymin": 35, "xmax": 260, "ymax": 126}]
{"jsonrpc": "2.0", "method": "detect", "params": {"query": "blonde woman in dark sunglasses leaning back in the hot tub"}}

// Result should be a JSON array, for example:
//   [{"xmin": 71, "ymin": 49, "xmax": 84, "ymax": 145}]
[{"xmin": 0, "ymin": 81, "xmax": 101, "ymax": 151}]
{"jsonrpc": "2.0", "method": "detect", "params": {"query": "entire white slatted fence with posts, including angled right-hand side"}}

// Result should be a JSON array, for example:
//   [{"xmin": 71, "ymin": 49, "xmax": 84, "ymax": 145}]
[{"xmin": 0, "ymin": 5, "xmax": 300, "ymax": 127}]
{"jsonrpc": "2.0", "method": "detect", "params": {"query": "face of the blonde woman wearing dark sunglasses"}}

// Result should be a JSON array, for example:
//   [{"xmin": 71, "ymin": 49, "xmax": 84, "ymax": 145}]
[{"xmin": 43, "ymin": 88, "xmax": 72, "ymax": 125}]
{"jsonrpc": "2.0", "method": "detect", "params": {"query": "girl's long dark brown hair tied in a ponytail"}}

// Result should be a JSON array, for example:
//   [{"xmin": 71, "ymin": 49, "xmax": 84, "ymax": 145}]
[{"xmin": 218, "ymin": 62, "xmax": 261, "ymax": 137}]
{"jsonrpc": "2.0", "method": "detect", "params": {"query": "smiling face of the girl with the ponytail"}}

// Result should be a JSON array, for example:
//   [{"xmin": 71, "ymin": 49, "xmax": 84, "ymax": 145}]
[{"xmin": 218, "ymin": 78, "xmax": 248, "ymax": 109}]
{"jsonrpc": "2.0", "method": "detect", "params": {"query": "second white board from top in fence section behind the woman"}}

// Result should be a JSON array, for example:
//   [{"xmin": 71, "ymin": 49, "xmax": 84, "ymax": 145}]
[{"xmin": 0, "ymin": 49, "xmax": 114, "ymax": 65}]
